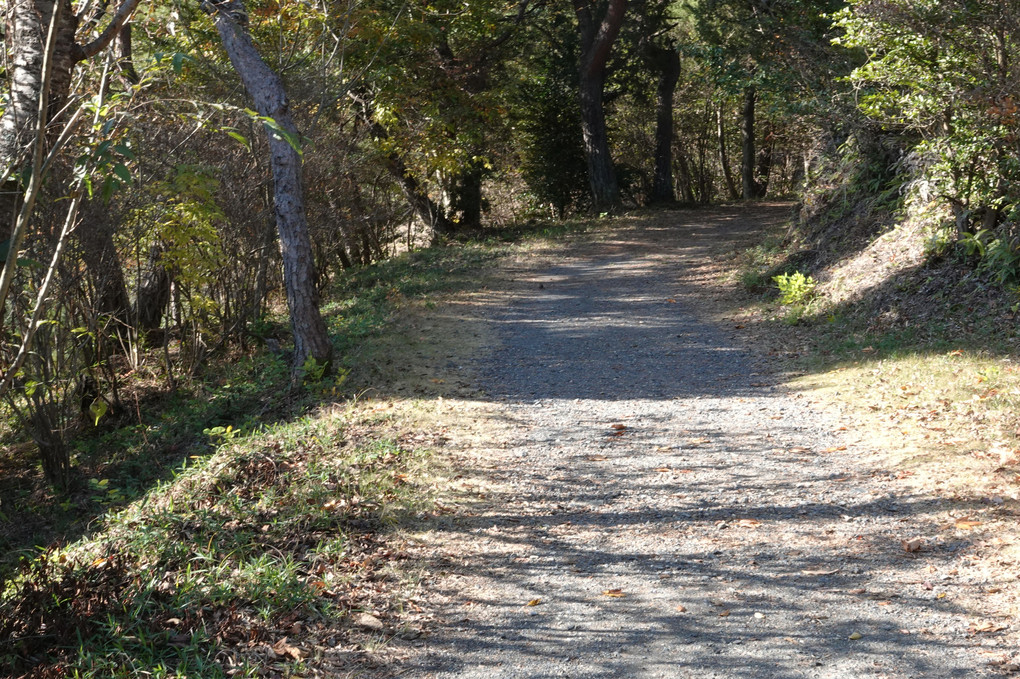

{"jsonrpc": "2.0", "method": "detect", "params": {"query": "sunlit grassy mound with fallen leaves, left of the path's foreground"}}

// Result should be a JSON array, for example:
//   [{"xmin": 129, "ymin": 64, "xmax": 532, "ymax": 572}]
[{"xmin": 0, "ymin": 411, "xmax": 431, "ymax": 677}]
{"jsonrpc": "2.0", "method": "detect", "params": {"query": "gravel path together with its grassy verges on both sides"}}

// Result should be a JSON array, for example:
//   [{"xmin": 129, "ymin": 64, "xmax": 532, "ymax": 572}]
[{"xmin": 0, "ymin": 205, "xmax": 1020, "ymax": 677}]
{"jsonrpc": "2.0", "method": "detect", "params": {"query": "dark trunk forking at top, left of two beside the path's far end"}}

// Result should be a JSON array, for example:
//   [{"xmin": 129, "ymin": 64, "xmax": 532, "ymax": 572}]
[{"xmin": 573, "ymin": 0, "xmax": 627, "ymax": 211}]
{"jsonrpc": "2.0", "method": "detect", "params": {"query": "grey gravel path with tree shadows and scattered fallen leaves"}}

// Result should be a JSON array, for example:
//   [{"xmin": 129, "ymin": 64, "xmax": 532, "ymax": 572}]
[{"xmin": 400, "ymin": 207, "xmax": 1010, "ymax": 679}]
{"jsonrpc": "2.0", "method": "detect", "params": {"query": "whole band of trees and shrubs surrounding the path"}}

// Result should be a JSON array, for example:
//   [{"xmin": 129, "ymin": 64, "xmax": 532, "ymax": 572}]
[{"xmin": 0, "ymin": 0, "xmax": 1020, "ymax": 513}]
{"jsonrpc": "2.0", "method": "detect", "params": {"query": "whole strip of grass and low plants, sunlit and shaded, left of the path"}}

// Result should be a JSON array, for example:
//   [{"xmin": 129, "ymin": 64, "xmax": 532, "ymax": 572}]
[{"xmin": 0, "ymin": 225, "xmax": 591, "ymax": 678}]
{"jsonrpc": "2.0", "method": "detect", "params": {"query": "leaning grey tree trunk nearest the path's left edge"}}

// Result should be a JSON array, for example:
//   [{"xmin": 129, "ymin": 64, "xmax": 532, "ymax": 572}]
[{"xmin": 207, "ymin": 0, "xmax": 333, "ymax": 376}]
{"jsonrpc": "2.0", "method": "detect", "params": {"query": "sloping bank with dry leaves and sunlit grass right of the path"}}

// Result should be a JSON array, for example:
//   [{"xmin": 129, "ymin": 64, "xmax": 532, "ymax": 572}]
[{"xmin": 730, "ymin": 203, "xmax": 1020, "ymax": 513}]
